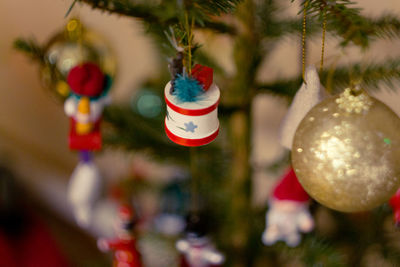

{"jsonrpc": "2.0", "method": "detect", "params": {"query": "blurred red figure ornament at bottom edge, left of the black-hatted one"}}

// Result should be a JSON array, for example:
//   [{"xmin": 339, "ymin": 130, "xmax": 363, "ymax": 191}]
[{"xmin": 97, "ymin": 205, "xmax": 143, "ymax": 267}]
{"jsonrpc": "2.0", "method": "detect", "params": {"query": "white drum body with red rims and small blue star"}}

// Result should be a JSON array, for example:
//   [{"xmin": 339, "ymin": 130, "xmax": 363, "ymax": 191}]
[{"xmin": 165, "ymin": 82, "xmax": 220, "ymax": 146}]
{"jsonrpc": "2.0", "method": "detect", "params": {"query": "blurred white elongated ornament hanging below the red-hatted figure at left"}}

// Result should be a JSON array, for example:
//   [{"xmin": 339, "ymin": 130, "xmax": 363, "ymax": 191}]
[{"xmin": 68, "ymin": 162, "xmax": 101, "ymax": 228}]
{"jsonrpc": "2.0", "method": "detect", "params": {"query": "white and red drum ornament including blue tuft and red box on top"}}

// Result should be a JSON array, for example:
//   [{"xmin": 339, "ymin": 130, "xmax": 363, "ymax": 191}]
[{"xmin": 164, "ymin": 65, "xmax": 220, "ymax": 146}]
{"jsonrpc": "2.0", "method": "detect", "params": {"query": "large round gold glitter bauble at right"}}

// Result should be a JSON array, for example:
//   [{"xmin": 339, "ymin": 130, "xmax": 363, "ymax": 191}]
[{"xmin": 292, "ymin": 89, "xmax": 400, "ymax": 212}]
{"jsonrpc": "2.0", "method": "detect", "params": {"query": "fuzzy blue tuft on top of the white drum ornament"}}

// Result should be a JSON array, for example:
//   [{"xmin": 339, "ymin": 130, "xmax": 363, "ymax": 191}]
[{"xmin": 173, "ymin": 74, "xmax": 204, "ymax": 102}]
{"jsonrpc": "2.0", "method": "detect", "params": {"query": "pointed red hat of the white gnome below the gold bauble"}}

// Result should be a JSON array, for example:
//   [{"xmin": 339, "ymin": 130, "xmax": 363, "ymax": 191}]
[{"xmin": 273, "ymin": 168, "xmax": 310, "ymax": 202}]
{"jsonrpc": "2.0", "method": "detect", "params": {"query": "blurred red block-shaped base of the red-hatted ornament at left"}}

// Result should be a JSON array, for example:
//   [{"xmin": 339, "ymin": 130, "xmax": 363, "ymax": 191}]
[{"xmin": 68, "ymin": 118, "xmax": 102, "ymax": 151}]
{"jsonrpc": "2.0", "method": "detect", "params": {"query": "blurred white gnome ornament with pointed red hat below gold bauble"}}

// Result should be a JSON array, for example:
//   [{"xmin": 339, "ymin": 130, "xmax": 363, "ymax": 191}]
[{"xmin": 262, "ymin": 168, "xmax": 314, "ymax": 247}]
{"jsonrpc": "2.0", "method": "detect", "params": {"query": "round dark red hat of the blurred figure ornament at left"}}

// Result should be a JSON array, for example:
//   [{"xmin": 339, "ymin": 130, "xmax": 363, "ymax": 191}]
[{"xmin": 67, "ymin": 63, "xmax": 105, "ymax": 97}]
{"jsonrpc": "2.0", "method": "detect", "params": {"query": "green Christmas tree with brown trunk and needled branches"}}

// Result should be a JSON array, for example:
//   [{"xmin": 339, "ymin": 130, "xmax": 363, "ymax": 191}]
[{"xmin": 15, "ymin": 0, "xmax": 400, "ymax": 266}]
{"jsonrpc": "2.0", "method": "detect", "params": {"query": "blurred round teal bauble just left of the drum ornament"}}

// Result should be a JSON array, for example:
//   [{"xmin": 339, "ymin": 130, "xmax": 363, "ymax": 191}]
[{"xmin": 131, "ymin": 89, "xmax": 162, "ymax": 118}]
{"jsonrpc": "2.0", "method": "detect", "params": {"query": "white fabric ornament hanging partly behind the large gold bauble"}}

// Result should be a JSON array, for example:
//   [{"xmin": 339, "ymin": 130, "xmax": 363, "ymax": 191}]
[{"xmin": 279, "ymin": 66, "xmax": 325, "ymax": 150}]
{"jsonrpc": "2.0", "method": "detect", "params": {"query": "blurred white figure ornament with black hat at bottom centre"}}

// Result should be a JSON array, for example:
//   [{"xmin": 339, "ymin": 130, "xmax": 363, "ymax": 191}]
[{"xmin": 176, "ymin": 214, "xmax": 225, "ymax": 267}]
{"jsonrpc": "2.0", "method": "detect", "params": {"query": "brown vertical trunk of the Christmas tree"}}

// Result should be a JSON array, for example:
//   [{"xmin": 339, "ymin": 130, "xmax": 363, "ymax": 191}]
[{"xmin": 224, "ymin": 0, "xmax": 261, "ymax": 267}]
